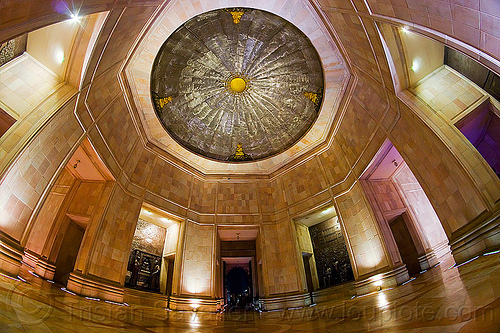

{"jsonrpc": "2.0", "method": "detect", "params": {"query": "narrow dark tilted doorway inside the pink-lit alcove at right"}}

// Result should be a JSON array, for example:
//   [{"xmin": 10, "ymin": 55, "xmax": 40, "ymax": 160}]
[{"xmin": 389, "ymin": 215, "xmax": 420, "ymax": 275}]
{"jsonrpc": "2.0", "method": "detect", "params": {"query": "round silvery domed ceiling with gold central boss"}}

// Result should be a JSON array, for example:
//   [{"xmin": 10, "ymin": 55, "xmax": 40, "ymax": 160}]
[{"xmin": 151, "ymin": 8, "xmax": 324, "ymax": 162}]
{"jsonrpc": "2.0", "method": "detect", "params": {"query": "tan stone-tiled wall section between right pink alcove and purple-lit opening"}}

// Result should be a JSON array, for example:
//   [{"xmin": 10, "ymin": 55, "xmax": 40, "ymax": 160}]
[{"xmin": 392, "ymin": 104, "xmax": 486, "ymax": 234}]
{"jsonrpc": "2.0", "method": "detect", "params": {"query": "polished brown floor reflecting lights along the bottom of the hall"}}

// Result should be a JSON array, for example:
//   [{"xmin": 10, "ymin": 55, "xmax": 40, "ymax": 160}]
[{"xmin": 0, "ymin": 253, "xmax": 500, "ymax": 333}]
